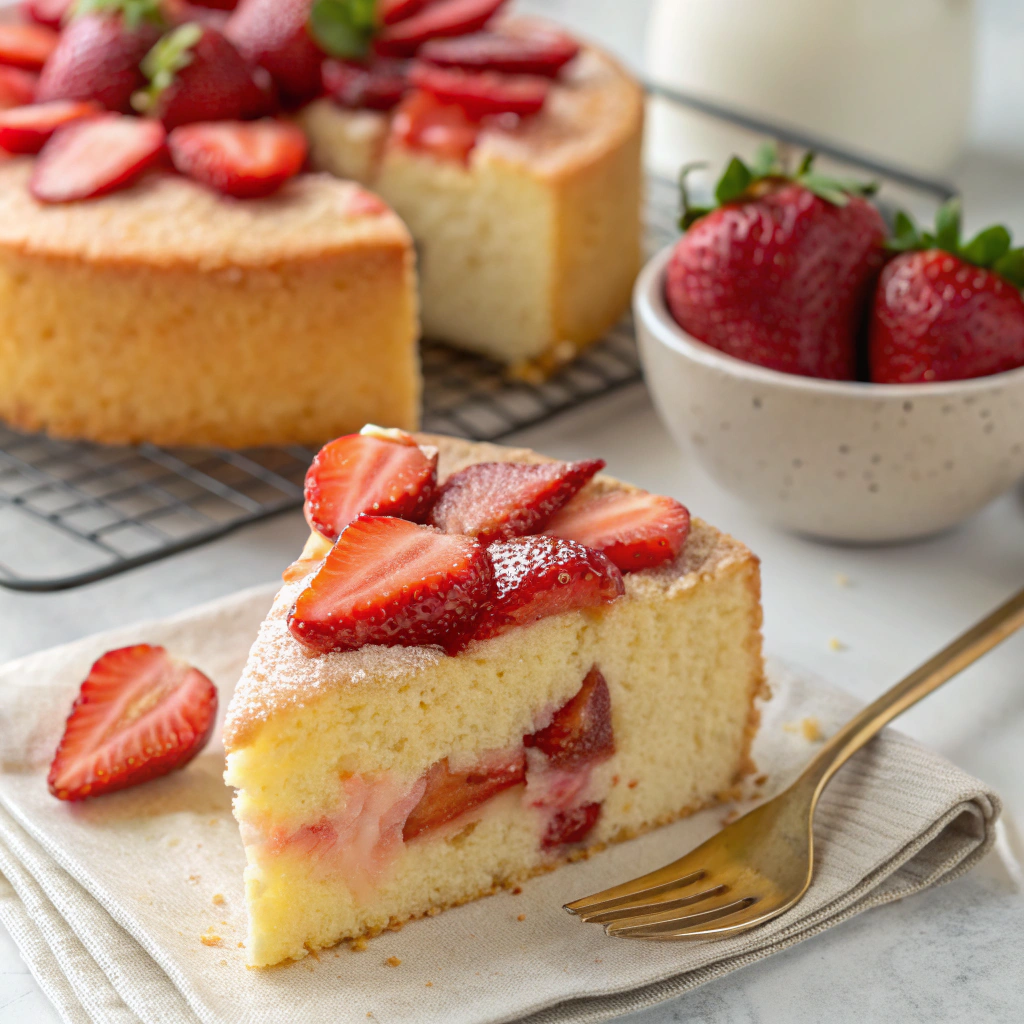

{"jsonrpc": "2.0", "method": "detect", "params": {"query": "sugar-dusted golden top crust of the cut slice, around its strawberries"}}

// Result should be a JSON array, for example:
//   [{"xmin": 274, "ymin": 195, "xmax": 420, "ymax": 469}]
[{"xmin": 223, "ymin": 434, "xmax": 760, "ymax": 754}]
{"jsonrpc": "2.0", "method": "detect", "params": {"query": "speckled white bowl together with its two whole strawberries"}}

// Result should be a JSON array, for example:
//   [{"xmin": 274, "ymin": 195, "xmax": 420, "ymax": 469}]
[{"xmin": 634, "ymin": 146, "xmax": 1024, "ymax": 543}]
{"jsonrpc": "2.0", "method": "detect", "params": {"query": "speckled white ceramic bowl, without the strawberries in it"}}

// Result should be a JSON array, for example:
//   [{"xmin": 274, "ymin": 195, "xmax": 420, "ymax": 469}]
[{"xmin": 633, "ymin": 247, "xmax": 1024, "ymax": 543}]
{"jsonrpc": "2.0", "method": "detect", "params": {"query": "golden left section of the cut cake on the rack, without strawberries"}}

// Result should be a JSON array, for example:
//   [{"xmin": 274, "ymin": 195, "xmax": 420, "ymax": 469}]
[{"xmin": 0, "ymin": 161, "xmax": 420, "ymax": 447}]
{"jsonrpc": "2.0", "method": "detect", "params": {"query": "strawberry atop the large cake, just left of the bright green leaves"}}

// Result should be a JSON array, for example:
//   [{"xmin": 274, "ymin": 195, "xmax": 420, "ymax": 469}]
[{"xmin": 224, "ymin": 0, "xmax": 324, "ymax": 102}]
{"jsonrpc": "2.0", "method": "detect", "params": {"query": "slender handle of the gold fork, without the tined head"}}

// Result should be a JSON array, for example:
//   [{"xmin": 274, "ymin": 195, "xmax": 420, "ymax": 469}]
[{"xmin": 802, "ymin": 590, "xmax": 1024, "ymax": 797}]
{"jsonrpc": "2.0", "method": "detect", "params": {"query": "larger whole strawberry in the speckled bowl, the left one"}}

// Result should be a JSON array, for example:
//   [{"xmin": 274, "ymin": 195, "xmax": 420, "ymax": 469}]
[{"xmin": 666, "ymin": 146, "xmax": 886, "ymax": 380}]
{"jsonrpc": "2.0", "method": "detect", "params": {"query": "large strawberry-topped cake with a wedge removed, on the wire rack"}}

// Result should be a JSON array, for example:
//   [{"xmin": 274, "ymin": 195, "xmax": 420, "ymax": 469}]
[{"xmin": 0, "ymin": 0, "xmax": 642, "ymax": 446}]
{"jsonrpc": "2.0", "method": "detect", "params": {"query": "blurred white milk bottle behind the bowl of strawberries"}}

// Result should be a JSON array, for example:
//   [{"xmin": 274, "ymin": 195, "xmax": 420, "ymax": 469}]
[{"xmin": 646, "ymin": 0, "xmax": 974, "ymax": 173}]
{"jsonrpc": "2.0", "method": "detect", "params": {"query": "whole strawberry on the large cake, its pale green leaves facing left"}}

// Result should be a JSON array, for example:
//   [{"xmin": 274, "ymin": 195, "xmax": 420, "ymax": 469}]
[{"xmin": 132, "ymin": 22, "xmax": 267, "ymax": 130}]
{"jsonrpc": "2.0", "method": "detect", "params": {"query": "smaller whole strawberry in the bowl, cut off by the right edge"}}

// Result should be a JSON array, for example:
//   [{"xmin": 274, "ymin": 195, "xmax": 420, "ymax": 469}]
[{"xmin": 868, "ymin": 200, "xmax": 1024, "ymax": 384}]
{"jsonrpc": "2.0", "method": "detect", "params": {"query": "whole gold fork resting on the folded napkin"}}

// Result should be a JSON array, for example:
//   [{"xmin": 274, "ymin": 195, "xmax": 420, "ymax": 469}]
[{"xmin": 565, "ymin": 590, "xmax": 1024, "ymax": 940}]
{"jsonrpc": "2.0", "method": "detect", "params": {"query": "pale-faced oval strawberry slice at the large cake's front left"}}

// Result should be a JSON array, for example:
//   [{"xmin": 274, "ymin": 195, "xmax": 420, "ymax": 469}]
[{"xmin": 29, "ymin": 114, "xmax": 167, "ymax": 203}]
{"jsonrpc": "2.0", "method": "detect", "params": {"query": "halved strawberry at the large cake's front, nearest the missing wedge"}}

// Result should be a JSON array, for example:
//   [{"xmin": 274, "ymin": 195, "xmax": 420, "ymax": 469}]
[{"xmin": 168, "ymin": 118, "xmax": 307, "ymax": 199}]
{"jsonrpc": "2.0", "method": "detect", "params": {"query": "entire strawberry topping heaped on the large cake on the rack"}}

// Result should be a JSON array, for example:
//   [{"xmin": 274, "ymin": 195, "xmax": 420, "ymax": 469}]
[{"xmin": 0, "ymin": 0, "xmax": 580, "ymax": 203}]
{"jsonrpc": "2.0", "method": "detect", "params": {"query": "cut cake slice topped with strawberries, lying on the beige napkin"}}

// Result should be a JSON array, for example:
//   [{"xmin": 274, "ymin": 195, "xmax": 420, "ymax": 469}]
[{"xmin": 224, "ymin": 430, "xmax": 763, "ymax": 966}]
